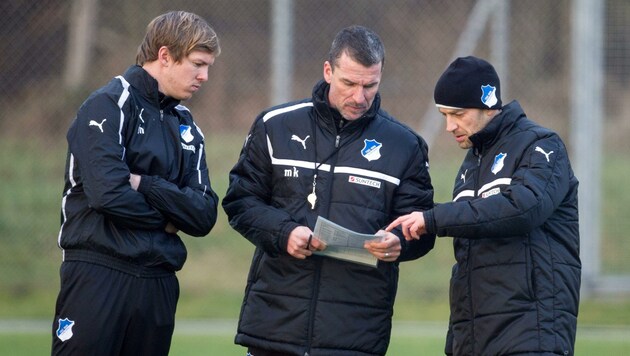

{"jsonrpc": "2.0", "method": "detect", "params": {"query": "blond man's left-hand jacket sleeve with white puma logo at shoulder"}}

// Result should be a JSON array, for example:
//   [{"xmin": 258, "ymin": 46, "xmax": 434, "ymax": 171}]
[{"xmin": 67, "ymin": 89, "xmax": 166, "ymax": 229}]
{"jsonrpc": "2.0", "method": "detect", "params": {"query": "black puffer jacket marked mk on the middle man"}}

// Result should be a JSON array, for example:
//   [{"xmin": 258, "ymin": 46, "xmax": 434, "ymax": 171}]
[{"xmin": 223, "ymin": 82, "xmax": 435, "ymax": 355}]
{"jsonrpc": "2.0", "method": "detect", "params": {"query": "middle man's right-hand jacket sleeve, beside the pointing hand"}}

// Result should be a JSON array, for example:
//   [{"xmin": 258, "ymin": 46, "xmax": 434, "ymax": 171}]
[{"xmin": 391, "ymin": 137, "xmax": 435, "ymax": 261}]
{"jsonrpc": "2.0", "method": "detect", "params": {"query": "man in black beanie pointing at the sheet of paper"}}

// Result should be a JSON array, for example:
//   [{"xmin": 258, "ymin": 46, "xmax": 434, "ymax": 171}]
[{"xmin": 386, "ymin": 57, "xmax": 581, "ymax": 355}]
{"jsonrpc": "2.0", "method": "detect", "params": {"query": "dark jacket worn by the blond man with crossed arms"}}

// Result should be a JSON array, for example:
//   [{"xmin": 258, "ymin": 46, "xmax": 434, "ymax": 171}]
[{"xmin": 58, "ymin": 66, "xmax": 218, "ymax": 274}]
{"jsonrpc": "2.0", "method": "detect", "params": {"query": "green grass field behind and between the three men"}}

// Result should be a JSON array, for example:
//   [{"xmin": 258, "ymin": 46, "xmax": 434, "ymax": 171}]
[{"xmin": 0, "ymin": 135, "xmax": 630, "ymax": 355}]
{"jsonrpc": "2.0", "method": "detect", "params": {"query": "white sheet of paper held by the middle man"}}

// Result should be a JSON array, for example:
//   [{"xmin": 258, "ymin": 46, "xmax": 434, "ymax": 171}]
[{"xmin": 313, "ymin": 216, "xmax": 382, "ymax": 267}]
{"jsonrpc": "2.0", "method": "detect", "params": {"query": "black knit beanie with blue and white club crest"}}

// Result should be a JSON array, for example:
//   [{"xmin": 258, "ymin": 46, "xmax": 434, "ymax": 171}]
[{"xmin": 433, "ymin": 56, "xmax": 501, "ymax": 109}]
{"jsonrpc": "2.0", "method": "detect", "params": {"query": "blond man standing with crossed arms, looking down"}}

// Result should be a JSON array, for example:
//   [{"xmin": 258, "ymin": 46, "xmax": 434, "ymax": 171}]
[{"xmin": 52, "ymin": 11, "xmax": 220, "ymax": 355}]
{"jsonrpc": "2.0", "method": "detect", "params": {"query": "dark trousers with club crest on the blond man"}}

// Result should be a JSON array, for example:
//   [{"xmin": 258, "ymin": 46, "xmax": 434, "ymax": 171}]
[{"xmin": 52, "ymin": 261, "xmax": 179, "ymax": 356}]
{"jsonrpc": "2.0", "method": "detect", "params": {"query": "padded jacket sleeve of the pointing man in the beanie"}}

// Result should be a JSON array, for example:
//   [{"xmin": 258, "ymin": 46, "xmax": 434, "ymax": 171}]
[{"xmin": 424, "ymin": 136, "xmax": 574, "ymax": 239}]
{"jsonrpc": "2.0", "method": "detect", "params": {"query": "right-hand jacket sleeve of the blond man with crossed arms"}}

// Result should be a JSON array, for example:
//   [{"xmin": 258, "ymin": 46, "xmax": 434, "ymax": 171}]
[{"xmin": 138, "ymin": 121, "xmax": 219, "ymax": 236}]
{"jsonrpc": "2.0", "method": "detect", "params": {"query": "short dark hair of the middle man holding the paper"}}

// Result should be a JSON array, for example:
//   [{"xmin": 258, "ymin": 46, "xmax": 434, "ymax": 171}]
[{"xmin": 328, "ymin": 25, "xmax": 385, "ymax": 68}]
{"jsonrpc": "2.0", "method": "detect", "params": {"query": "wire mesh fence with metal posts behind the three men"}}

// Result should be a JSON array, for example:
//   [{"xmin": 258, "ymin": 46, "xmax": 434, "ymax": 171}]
[{"xmin": 0, "ymin": 0, "xmax": 630, "ymax": 317}]
